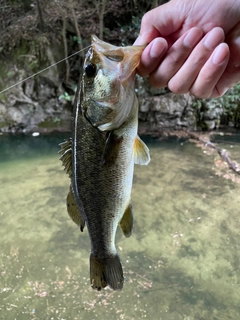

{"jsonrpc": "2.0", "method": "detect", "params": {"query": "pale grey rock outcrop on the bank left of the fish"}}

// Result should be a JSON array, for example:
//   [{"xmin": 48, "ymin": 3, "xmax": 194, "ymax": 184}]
[{"xmin": 0, "ymin": 77, "xmax": 71, "ymax": 133}]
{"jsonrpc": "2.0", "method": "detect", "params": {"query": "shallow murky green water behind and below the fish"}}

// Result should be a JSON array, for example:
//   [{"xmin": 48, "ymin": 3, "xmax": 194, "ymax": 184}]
[{"xmin": 0, "ymin": 135, "xmax": 240, "ymax": 320}]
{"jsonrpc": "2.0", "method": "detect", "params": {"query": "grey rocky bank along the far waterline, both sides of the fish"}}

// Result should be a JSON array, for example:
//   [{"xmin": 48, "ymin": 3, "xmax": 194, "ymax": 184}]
[{"xmin": 0, "ymin": 67, "xmax": 240, "ymax": 134}]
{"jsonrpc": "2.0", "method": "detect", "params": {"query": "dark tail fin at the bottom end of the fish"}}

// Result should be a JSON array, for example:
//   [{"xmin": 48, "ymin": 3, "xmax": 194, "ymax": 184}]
[{"xmin": 90, "ymin": 253, "xmax": 124, "ymax": 291}]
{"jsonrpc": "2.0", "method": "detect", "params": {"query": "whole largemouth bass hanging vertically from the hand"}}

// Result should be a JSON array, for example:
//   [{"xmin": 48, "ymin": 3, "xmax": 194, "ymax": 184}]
[{"xmin": 60, "ymin": 36, "xmax": 150, "ymax": 290}]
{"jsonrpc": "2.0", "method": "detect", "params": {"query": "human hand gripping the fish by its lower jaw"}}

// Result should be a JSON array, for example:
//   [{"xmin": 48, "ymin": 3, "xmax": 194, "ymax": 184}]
[{"xmin": 135, "ymin": 0, "xmax": 240, "ymax": 98}]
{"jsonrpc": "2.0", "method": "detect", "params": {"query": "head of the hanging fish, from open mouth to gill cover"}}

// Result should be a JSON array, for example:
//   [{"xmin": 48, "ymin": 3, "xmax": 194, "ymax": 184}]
[{"xmin": 82, "ymin": 36, "xmax": 144, "ymax": 131}]
